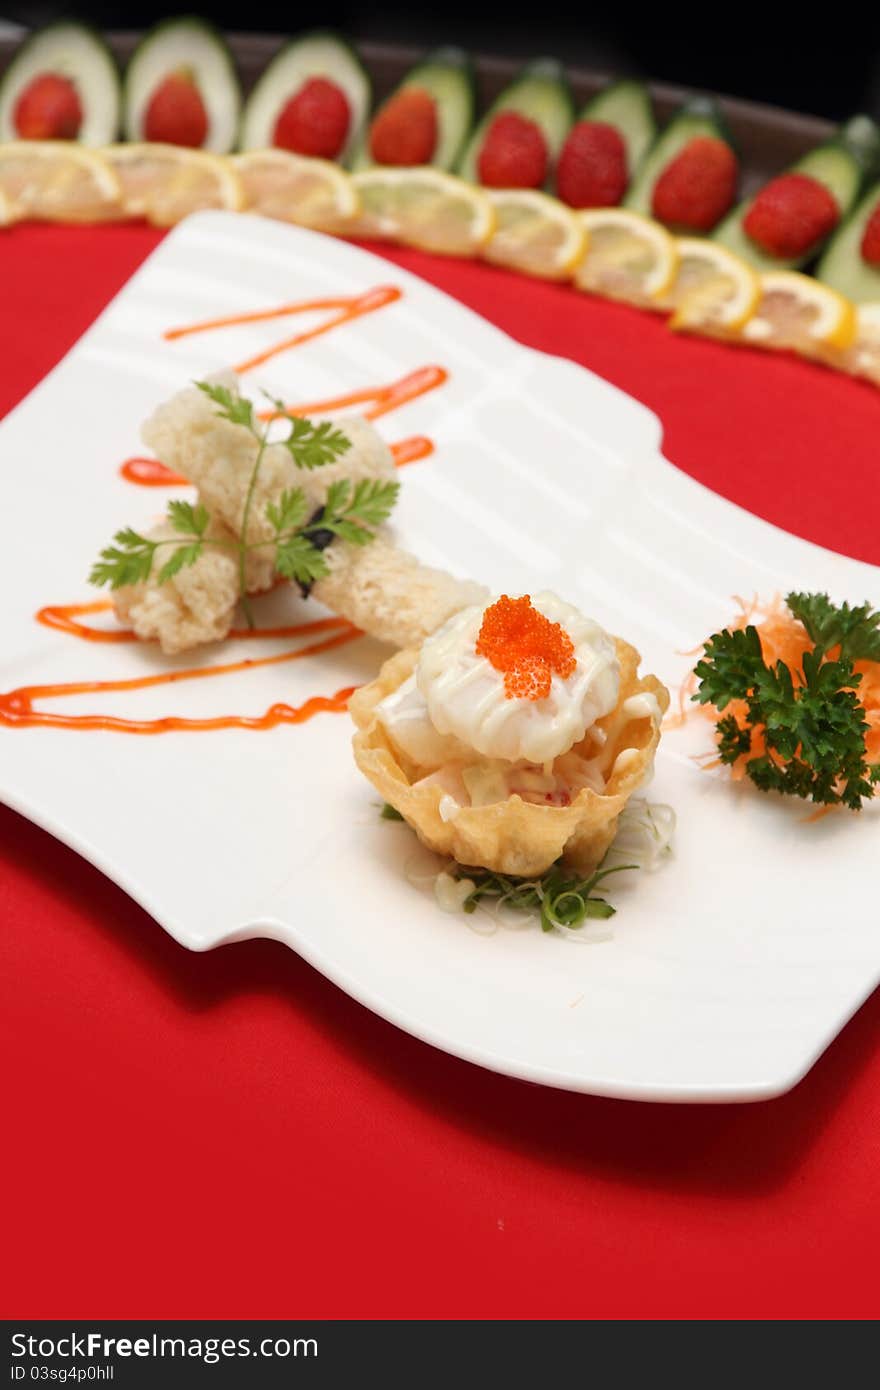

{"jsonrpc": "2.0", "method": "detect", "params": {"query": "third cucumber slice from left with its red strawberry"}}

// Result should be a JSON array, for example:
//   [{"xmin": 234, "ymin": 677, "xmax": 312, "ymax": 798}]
[{"xmin": 242, "ymin": 32, "xmax": 370, "ymax": 164}]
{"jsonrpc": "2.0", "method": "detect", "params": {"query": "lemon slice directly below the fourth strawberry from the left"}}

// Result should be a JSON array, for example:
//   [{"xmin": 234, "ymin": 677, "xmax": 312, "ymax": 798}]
[{"xmin": 352, "ymin": 165, "xmax": 495, "ymax": 256}]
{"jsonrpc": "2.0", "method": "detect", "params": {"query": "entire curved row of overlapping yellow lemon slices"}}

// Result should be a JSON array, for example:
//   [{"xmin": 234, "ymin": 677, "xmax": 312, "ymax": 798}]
[{"xmin": 0, "ymin": 142, "xmax": 880, "ymax": 385}]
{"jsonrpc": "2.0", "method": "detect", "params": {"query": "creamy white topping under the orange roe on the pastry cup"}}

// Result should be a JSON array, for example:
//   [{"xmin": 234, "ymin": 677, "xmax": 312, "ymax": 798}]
[{"xmin": 414, "ymin": 591, "xmax": 620, "ymax": 765}]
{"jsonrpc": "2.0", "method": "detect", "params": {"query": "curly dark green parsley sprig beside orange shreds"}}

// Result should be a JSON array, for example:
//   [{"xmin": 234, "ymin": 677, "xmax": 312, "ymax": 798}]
[{"xmin": 692, "ymin": 594, "xmax": 880, "ymax": 810}]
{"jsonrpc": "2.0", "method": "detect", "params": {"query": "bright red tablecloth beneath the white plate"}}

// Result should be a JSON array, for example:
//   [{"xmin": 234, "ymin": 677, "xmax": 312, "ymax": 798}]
[{"xmin": 0, "ymin": 227, "xmax": 880, "ymax": 1318}]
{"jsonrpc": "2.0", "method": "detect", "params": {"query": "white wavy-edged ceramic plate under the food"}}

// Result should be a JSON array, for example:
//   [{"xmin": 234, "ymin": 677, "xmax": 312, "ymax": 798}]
[{"xmin": 0, "ymin": 213, "xmax": 880, "ymax": 1099}]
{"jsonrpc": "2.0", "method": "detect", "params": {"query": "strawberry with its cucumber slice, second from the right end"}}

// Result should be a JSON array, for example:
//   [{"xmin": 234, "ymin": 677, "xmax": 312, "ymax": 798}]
[{"xmin": 715, "ymin": 115, "xmax": 880, "ymax": 271}]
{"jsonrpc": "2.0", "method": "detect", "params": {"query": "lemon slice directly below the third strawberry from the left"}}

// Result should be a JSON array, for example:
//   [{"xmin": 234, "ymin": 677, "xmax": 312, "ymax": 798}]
[{"xmin": 231, "ymin": 150, "xmax": 360, "ymax": 232}]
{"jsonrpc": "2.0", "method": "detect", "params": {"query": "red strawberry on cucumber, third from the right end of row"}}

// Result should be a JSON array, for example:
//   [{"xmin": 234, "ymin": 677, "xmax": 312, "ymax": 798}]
[{"xmin": 651, "ymin": 135, "xmax": 738, "ymax": 232}]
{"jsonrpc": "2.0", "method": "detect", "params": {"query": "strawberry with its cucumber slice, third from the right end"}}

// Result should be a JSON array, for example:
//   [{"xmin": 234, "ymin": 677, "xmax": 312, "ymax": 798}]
[{"xmin": 626, "ymin": 97, "xmax": 740, "ymax": 234}]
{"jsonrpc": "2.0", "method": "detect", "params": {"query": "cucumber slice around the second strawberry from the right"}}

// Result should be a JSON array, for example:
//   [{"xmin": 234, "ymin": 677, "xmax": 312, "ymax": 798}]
[{"xmin": 713, "ymin": 115, "xmax": 880, "ymax": 270}]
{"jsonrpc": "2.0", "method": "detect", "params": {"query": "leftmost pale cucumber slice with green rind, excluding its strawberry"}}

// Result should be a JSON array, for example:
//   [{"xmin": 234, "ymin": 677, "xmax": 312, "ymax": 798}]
[{"xmin": 0, "ymin": 21, "xmax": 120, "ymax": 145}]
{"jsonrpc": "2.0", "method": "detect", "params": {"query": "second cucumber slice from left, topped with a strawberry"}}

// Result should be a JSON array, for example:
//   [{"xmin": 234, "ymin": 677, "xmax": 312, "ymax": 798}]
[{"xmin": 124, "ymin": 15, "xmax": 242, "ymax": 154}]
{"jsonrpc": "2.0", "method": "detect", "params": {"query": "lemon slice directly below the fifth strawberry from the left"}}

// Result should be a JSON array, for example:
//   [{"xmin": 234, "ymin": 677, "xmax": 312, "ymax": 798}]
[{"xmin": 482, "ymin": 188, "xmax": 587, "ymax": 279}]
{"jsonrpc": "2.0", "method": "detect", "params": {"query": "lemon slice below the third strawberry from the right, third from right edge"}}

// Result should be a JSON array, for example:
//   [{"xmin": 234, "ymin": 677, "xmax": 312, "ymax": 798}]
[{"xmin": 666, "ymin": 236, "xmax": 760, "ymax": 331}]
